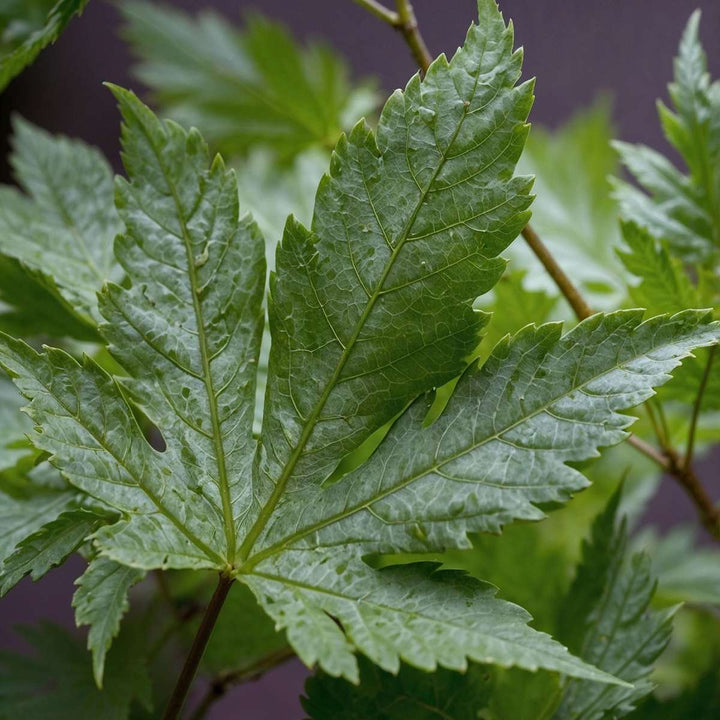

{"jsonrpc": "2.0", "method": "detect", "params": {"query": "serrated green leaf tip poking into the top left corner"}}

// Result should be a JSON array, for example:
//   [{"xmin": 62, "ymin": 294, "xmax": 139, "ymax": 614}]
[{"xmin": 0, "ymin": 0, "xmax": 88, "ymax": 91}]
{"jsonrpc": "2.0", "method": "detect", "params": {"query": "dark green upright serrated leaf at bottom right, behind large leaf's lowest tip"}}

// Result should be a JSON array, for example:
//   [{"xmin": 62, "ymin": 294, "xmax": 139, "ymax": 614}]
[{"xmin": 554, "ymin": 492, "xmax": 675, "ymax": 720}]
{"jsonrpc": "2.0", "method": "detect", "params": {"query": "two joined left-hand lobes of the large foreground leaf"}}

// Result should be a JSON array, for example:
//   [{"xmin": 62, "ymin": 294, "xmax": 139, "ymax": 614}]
[{"xmin": 3, "ymin": 91, "xmax": 264, "ymax": 567}]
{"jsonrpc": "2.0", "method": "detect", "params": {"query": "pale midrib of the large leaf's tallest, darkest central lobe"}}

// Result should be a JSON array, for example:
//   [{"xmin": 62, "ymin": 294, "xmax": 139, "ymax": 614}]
[{"xmin": 239, "ymin": 84, "xmax": 480, "ymax": 562}]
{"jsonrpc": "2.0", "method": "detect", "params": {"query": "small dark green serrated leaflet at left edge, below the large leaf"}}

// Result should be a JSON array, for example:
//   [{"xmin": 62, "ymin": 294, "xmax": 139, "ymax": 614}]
[{"xmin": 0, "ymin": 508, "xmax": 111, "ymax": 595}]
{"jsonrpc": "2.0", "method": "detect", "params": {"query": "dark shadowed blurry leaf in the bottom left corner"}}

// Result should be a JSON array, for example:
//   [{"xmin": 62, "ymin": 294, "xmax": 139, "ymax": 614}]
[{"xmin": 0, "ymin": 622, "xmax": 152, "ymax": 720}]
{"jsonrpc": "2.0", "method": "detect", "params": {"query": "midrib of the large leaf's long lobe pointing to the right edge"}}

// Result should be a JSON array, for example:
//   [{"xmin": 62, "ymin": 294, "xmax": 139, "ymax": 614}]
[{"xmin": 244, "ymin": 318, "xmax": 708, "ymax": 574}]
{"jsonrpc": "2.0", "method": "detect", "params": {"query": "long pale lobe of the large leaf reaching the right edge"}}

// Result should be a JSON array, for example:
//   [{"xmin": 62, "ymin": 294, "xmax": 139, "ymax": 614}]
[{"xmin": 250, "ymin": 310, "xmax": 719, "ymax": 558}]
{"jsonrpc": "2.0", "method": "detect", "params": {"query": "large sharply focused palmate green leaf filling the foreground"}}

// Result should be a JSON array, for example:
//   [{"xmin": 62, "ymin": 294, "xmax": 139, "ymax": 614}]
[{"xmin": 0, "ymin": 0, "xmax": 719, "ymax": 682}]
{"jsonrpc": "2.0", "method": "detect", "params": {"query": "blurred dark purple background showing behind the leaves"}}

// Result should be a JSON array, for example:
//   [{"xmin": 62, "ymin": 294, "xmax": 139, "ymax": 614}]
[{"xmin": 0, "ymin": 0, "xmax": 720, "ymax": 720}]
